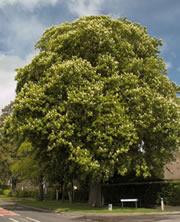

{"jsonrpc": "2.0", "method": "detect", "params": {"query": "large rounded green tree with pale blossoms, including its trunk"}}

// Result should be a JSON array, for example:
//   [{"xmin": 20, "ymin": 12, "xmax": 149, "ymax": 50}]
[{"xmin": 12, "ymin": 16, "xmax": 179, "ymax": 206}]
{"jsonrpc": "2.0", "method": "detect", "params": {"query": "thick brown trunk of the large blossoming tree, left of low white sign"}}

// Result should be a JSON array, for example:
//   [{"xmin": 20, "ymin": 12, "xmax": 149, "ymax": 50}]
[{"xmin": 89, "ymin": 182, "xmax": 103, "ymax": 207}]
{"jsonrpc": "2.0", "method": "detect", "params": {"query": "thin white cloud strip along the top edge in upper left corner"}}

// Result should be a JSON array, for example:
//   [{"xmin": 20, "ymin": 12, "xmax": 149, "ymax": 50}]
[{"xmin": 0, "ymin": 0, "xmax": 59, "ymax": 10}]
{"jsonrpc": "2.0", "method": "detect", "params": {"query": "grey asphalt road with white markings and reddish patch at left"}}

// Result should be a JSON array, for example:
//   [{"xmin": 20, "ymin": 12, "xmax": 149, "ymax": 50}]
[{"xmin": 0, "ymin": 202, "xmax": 180, "ymax": 222}]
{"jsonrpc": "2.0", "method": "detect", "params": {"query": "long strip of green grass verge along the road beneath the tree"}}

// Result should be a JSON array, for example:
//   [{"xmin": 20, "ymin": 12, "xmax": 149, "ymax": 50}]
[{"xmin": 0, "ymin": 195, "xmax": 180, "ymax": 214}]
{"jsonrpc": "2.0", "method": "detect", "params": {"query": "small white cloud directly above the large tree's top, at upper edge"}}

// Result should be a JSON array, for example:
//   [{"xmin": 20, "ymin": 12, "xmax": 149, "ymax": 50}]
[{"xmin": 68, "ymin": 0, "xmax": 105, "ymax": 16}]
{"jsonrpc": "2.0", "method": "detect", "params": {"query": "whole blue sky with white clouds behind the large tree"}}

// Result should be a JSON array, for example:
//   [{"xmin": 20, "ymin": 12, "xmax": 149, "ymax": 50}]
[{"xmin": 0, "ymin": 0, "xmax": 180, "ymax": 109}]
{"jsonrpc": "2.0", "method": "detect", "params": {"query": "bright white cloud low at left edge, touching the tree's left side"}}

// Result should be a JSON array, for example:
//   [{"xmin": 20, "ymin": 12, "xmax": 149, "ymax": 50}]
[{"xmin": 0, "ymin": 53, "xmax": 35, "ymax": 109}]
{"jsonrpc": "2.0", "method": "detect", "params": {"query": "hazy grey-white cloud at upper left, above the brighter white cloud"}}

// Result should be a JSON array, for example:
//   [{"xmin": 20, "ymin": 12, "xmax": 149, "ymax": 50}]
[{"xmin": 0, "ymin": 15, "xmax": 47, "ymax": 57}]
